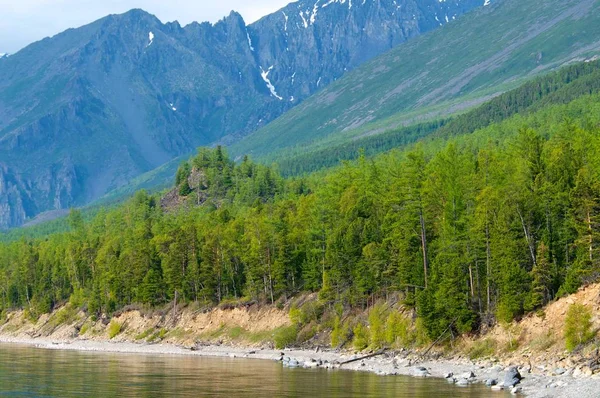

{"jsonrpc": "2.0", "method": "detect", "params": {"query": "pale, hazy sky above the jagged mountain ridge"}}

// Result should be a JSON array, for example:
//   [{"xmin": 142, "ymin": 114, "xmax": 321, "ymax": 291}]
[{"xmin": 0, "ymin": 0, "xmax": 292, "ymax": 53}]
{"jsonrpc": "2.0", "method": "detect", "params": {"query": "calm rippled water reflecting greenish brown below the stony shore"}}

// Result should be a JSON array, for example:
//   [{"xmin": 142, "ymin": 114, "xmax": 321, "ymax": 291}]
[{"xmin": 0, "ymin": 345, "xmax": 507, "ymax": 398}]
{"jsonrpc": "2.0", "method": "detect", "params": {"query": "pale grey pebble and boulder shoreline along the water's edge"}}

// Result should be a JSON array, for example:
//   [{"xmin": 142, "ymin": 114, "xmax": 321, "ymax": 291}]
[{"xmin": 0, "ymin": 335, "xmax": 600, "ymax": 398}]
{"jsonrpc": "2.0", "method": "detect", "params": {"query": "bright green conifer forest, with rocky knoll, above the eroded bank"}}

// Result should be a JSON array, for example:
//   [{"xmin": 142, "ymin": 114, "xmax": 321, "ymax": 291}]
[{"xmin": 0, "ymin": 89, "xmax": 600, "ymax": 338}]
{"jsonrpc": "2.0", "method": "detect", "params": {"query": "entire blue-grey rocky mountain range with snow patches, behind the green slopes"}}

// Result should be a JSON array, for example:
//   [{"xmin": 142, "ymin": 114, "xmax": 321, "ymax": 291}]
[{"xmin": 0, "ymin": 0, "xmax": 487, "ymax": 228}]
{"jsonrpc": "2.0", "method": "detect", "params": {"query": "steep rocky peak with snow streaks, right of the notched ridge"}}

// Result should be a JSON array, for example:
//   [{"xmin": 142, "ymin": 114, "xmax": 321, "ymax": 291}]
[{"xmin": 248, "ymin": 0, "xmax": 484, "ymax": 115}]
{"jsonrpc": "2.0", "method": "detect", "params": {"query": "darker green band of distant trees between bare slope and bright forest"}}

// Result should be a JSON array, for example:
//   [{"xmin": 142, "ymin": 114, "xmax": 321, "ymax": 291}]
[{"xmin": 274, "ymin": 61, "xmax": 600, "ymax": 175}]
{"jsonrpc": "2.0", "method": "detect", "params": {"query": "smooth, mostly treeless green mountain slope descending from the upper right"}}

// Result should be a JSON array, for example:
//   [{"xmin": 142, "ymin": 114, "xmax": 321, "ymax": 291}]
[{"xmin": 232, "ymin": 0, "xmax": 600, "ymax": 160}]
